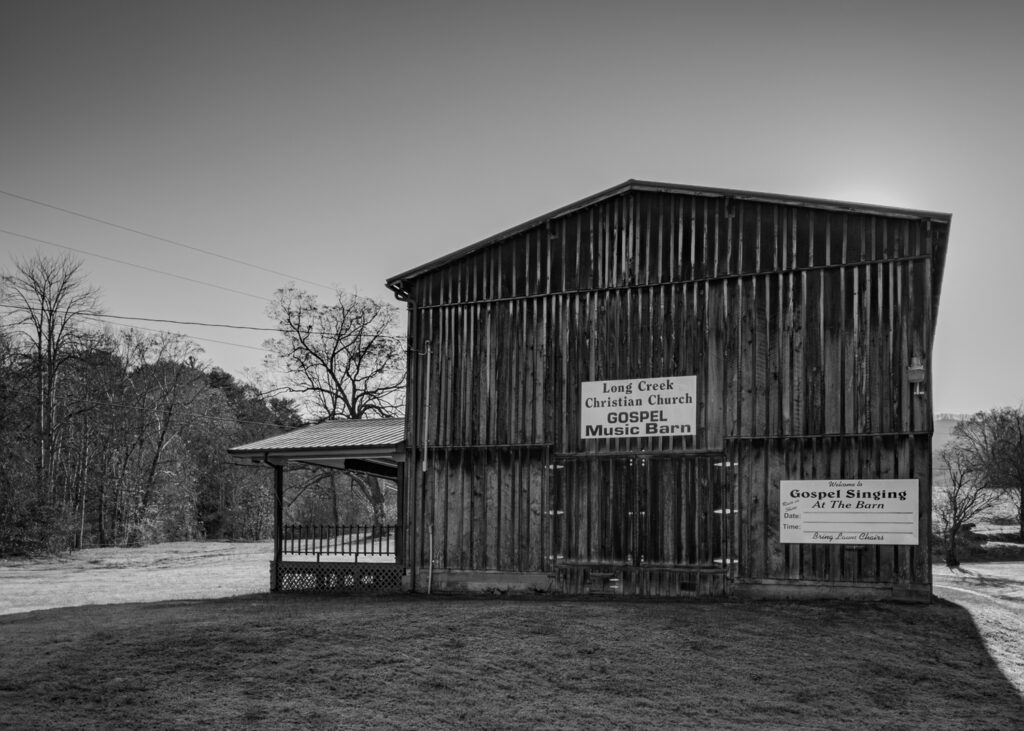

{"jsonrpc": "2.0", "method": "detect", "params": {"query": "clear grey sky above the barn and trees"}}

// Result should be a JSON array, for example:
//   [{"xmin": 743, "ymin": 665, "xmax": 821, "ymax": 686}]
[{"xmin": 0, "ymin": 0, "xmax": 1024, "ymax": 414}]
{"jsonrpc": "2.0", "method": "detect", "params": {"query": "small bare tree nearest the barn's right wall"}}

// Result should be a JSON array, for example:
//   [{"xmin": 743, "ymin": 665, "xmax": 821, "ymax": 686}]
[{"xmin": 935, "ymin": 441, "xmax": 999, "ymax": 568}]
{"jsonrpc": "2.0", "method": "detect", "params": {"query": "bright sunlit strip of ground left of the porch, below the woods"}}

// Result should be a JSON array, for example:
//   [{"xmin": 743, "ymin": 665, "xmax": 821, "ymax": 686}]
[{"xmin": 0, "ymin": 541, "xmax": 273, "ymax": 614}]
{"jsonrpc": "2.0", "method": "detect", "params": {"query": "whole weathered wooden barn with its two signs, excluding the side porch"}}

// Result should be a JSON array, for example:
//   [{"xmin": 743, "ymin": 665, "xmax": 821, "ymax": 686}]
[{"xmin": 387, "ymin": 180, "xmax": 950, "ymax": 601}]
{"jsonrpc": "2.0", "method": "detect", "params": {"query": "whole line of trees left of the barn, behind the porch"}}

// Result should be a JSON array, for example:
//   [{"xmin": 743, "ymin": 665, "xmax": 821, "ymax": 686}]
[{"xmin": 0, "ymin": 250, "xmax": 404, "ymax": 555}]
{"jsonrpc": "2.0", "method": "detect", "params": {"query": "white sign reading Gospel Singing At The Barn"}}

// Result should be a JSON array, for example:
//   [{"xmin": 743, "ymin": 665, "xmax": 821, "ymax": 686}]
[{"xmin": 779, "ymin": 480, "xmax": 920, "ymax": 546}]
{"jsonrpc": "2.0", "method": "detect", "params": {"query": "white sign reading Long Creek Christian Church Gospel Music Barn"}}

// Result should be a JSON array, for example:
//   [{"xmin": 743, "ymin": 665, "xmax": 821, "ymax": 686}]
[{"xmin": 580, "ymin": 376, "xmax": 697, "ymax": 439}]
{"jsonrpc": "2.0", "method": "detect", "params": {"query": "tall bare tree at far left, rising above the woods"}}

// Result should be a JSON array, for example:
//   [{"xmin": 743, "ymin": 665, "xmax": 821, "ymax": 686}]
[{"xmin": 2, "ymin": 254, "xmax": 99, "ymax": 498}]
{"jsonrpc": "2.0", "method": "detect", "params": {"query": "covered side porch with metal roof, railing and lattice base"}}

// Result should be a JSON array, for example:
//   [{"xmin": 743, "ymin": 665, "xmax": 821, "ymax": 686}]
[{"xmin": 228, "ymin": 419, "xmax": 406, "ymax": 593}]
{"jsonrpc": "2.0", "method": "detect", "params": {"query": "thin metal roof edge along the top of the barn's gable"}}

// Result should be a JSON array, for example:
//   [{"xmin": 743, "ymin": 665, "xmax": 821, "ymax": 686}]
[{"xmin": 386, "ymin": 180, "xmax": 952, "ymax": 299}]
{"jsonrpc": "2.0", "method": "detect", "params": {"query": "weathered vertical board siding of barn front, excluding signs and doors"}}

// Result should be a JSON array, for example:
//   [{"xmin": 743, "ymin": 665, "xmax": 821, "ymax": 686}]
[{"xmin": 395, "ymin": 190, "xmax": 947, "ymax": 583}]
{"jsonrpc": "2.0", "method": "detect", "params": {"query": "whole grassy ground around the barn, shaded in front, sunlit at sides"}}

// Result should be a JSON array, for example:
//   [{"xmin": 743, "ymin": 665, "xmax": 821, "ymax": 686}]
[{"xmin": 0, "ymin": 544, "xmax": 1024, "ymax": 729}]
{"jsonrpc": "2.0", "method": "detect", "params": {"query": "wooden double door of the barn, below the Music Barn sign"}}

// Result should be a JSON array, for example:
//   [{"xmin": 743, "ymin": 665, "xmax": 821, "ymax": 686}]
[{"xmin": 551, "ymin": 456, "xmax": 736, "ymax": 568}]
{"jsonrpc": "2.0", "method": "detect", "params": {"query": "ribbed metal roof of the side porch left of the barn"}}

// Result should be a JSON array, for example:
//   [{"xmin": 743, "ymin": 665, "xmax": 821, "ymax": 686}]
[{"xmin": 227, "ymin": 418, "xmax": 406, "ymax": 479}]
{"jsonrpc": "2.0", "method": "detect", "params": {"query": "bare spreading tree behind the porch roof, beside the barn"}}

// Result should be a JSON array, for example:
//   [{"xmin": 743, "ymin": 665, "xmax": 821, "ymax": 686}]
[{"xmin": 264, "ymin": 288, "xmax": 406, "ymax": 523}]
